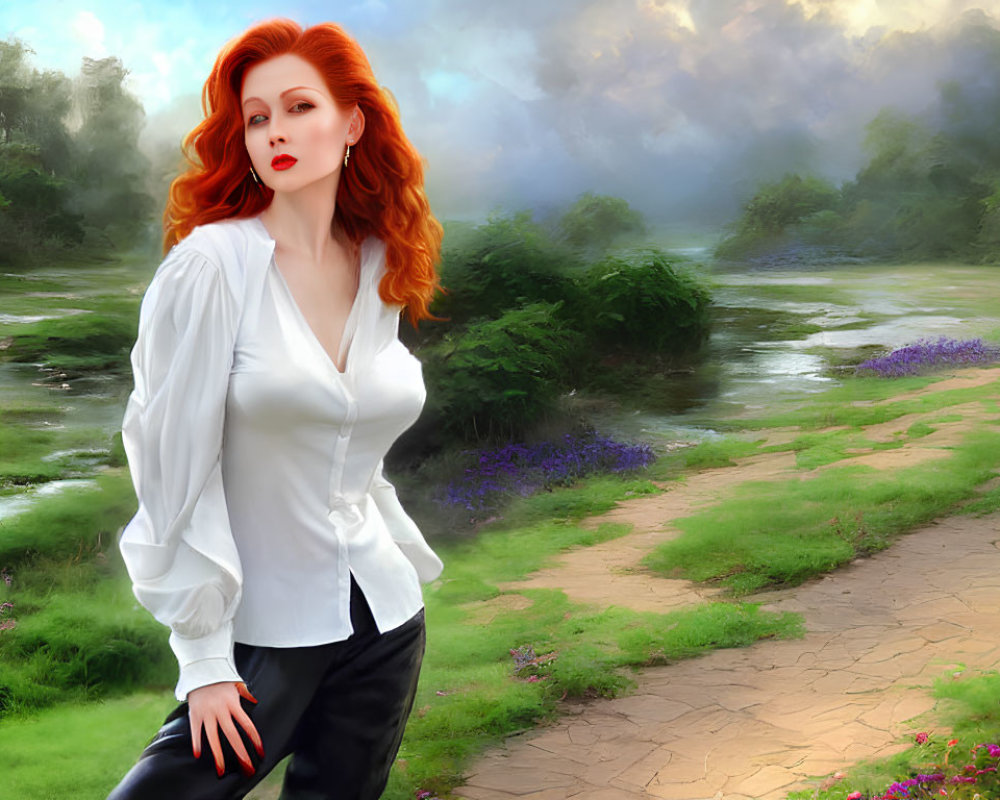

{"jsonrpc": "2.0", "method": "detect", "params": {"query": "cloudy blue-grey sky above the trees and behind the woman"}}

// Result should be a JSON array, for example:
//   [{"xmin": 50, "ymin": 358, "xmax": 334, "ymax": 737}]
[{"xmin": 0, "ymin": 0, "xmax": 1000, "ymax": 223}]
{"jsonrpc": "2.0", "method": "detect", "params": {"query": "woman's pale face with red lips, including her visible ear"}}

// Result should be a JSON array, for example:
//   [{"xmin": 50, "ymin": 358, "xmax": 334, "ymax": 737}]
[{"xmin": 240, "ymin": 54, "xmax": 364, "ymax": 192}]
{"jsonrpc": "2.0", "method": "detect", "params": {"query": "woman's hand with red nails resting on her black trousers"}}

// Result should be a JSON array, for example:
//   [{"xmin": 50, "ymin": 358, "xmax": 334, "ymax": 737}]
[{"xmin": 188, "ymin": 681, "xmax": 264, "ymax": 778}]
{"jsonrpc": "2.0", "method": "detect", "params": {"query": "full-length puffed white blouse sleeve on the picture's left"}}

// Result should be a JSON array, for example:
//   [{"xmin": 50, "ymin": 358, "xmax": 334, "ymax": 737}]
[{"xmin": 120, "ymin": 245, "xmax": 243, "ymax": 700}]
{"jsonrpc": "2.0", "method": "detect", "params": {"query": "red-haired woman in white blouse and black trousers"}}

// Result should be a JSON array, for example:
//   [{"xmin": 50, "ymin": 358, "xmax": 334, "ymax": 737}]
[{"xmin": 111, "ymin": 20, "xmax": 441, "ymax": 800}]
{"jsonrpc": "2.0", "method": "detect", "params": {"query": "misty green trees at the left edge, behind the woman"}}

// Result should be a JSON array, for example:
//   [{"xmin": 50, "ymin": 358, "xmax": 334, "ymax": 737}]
[{"xmin": 0, "ymin": 40, "xmax": 155, "ymax": 267}]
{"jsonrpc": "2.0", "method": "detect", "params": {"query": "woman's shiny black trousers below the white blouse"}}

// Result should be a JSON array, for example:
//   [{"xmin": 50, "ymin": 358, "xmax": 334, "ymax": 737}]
[{"xmin": 108, "ymin": 578, "xmax": 425, "ymax": 800}]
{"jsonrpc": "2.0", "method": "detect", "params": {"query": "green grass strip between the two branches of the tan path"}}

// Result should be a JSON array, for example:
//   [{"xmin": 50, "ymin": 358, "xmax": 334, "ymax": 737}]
[{"xmin": 644, "ymin": 431, "xmax": 1000, "ymax": 595}]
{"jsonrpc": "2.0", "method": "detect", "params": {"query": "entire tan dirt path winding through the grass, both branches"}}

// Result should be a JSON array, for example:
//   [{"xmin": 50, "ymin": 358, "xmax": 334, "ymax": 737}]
[{"xmin": 456, "ymin": 369, "xmax": 1000, "ymax": 800}]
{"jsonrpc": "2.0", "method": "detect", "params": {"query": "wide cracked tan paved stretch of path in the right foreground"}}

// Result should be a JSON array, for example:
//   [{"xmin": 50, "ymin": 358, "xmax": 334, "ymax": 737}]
[{"xmin": 457, "ymin": 517, "xmax": 1000, "ymax": 800}]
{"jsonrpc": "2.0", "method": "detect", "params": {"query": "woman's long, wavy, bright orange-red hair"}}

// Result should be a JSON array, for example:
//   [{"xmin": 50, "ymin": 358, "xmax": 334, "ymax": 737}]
[{"xmin": 163, "ymin": 19, "xmax": 443, "ymax": 323}]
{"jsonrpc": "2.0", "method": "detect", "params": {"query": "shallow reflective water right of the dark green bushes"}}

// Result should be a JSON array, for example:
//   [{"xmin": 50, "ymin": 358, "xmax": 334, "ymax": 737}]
[{"xmin": 593, "ymin": 258, "xmax": 1000, "ymax": 441}]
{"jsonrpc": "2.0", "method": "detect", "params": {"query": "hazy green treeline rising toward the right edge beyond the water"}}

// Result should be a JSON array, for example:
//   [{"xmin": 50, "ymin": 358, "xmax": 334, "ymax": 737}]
[{"xmin": 717, "ymin": 26, "xmax": 1000, "ymax": 262}]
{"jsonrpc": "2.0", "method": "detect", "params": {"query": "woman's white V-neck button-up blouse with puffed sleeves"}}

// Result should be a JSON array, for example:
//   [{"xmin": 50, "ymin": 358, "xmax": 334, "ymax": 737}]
[{"xmin": 120, "ymin": 217, "xmax": 442, "ymax": 700}]
